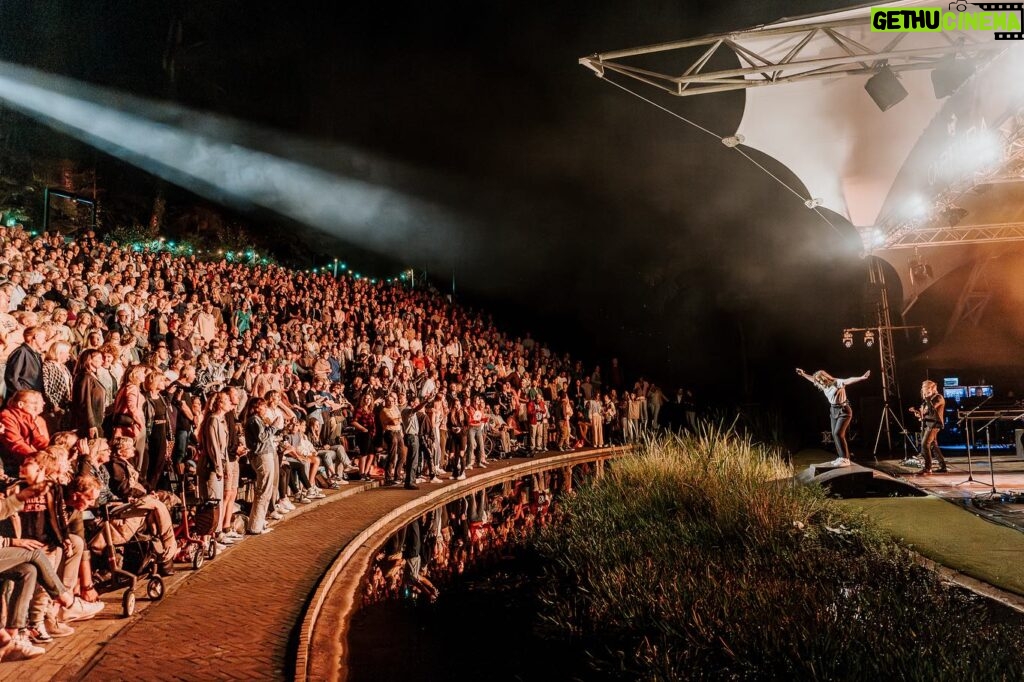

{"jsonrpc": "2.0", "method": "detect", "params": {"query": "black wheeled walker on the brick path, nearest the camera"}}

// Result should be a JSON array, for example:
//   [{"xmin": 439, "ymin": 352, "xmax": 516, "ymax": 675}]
[{"xmin": 93, "ymin": 502, "xmax": 164, "ymax": 617}]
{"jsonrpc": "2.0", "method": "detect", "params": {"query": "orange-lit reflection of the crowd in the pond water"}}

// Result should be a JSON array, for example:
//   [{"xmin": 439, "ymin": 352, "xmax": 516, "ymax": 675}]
[{"xmin": 364, "ymin": 465, "xmax": 591, "ymax": 604}]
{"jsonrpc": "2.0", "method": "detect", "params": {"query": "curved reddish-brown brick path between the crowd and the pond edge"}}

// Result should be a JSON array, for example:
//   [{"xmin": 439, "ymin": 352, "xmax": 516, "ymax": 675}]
[{"xmin": 61, "ymin": 451, "xmax": 606, "ymax": 682}]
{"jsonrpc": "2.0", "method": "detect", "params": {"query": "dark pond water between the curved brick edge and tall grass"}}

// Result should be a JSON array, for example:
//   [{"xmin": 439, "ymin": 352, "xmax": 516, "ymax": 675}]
[{"xmin": 347, "ymin": 467, "xmax": 614, "ymax": 682}]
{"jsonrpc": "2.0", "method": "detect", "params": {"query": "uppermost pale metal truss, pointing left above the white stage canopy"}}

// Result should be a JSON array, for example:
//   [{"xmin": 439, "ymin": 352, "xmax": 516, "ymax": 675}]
[{"xmin": 580, "ymin": 15, "xmax": 1006, "ymax": 97}]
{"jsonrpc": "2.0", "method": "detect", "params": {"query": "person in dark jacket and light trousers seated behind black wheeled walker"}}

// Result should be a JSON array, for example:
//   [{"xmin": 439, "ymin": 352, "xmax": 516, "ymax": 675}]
[{"xmin": 89, "ymin": 436, "xmax": 178, "ymax": 577}]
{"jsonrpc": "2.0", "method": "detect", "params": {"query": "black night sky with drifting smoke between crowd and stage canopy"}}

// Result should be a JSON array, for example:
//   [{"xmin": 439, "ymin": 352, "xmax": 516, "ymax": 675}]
[{"xmin": 0, "ymin": 0, "xmax": 892, "ymax": 436}]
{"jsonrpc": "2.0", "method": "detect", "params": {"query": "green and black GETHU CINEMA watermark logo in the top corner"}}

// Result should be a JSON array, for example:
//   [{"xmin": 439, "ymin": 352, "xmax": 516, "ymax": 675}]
[{"xmin": 871, "ymin": 2, "xmax": 1024, "ymax": 40}]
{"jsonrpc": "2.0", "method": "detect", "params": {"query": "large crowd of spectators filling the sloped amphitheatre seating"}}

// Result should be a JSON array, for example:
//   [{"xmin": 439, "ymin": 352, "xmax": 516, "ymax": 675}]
[{"xmin": 0, "ymin": 228, "xmax": 667, "ymax": 659}]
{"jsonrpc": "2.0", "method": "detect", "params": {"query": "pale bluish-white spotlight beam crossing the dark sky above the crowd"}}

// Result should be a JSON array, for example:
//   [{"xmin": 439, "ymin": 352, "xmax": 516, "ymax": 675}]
[{"xmin": 0, "ymin": 62, "xmax": 478, "ymax": 259}]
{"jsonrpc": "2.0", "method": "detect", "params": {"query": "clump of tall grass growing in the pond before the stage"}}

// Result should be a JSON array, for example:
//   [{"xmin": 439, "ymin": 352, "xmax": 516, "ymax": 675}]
[{"xmin": 537, "ymin": 426, "xmax": 1024, "ymax": 680}]
